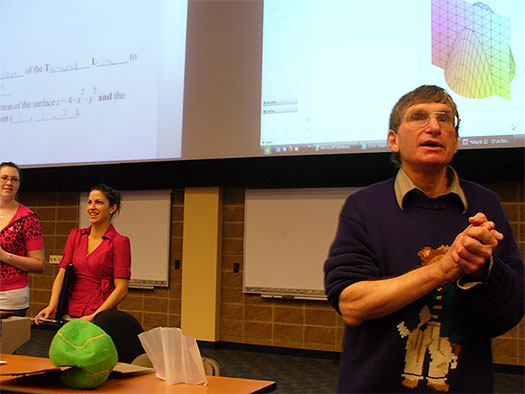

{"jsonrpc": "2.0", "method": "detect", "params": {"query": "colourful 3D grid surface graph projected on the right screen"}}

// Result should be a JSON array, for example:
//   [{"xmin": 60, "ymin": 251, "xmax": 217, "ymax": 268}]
[{"xmin": 432, "ymin": 0, "xmax": 516, "ymax": 100}]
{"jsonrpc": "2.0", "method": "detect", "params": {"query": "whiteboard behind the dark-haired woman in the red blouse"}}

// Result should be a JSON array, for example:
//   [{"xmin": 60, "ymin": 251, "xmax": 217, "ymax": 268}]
[{"xmin": 79, "ymin": 190, "xmax": 171, "ymax": 288}]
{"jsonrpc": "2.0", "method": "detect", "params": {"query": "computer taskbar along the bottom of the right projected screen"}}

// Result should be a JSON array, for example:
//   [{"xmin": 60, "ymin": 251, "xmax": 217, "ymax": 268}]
[{"xmin": 261, "ymin": 135, "xmax": 525, "ymax": 156}]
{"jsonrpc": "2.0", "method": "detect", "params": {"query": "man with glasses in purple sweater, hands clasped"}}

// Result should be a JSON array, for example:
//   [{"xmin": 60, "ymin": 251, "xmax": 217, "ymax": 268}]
[{"xmin": 324, "ymin": 85, "xmax": 524, "ymax": 393}]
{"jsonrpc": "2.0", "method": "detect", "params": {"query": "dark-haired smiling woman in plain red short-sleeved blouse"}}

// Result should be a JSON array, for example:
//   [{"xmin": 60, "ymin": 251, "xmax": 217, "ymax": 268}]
[{"xmin": 35, "ymin": 184, "xmax": 131, "ymax": 324}]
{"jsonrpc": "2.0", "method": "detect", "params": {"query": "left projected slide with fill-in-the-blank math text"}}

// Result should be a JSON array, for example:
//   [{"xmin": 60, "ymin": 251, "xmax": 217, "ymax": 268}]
[{"xmin": 0, "ymin": 0, "xmax": 187, "ymax": 165}]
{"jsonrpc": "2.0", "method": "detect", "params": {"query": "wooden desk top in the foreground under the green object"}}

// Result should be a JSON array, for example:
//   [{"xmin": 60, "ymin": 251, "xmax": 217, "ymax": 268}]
[{"xmin": 0, "ymin": 354, "xmax": 276, "ymax": 394}]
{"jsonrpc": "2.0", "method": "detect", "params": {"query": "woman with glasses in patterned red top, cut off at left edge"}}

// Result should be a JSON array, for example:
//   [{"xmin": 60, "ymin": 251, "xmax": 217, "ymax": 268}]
[{"xmin": 0, "ymin": 162, "xmax": 45, "ymax": 316}]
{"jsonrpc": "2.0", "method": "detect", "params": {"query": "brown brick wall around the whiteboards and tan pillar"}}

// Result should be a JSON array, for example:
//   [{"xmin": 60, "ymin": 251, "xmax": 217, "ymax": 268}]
[{"xmin": 19, "ymin": 183, "xmax": 525, "ymax": 365}]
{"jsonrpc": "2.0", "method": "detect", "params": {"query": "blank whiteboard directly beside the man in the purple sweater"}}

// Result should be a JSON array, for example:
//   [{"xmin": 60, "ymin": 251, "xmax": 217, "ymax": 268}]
[{"xmin": 243, "ymin": 188, "xmax": 358, "ymax": 299}]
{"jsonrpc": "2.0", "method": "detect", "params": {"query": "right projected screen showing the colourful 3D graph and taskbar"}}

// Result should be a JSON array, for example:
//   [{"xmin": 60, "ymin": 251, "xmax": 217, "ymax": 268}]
[{"xmin": 260, "ymin": 0, "xmax": 525, "ymax": 155}]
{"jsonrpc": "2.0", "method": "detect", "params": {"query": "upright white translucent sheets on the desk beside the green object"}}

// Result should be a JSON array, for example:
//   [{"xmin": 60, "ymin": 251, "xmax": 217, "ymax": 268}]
[{"xmin": 139, "ymin": 327, "xmax": 208, "ymax": 385}]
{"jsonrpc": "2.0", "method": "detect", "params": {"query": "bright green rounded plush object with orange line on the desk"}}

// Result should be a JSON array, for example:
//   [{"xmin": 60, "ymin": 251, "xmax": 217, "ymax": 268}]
[{"xmin": 49, "ymin": 320, "xmax": 118, "ymax": 389}]
